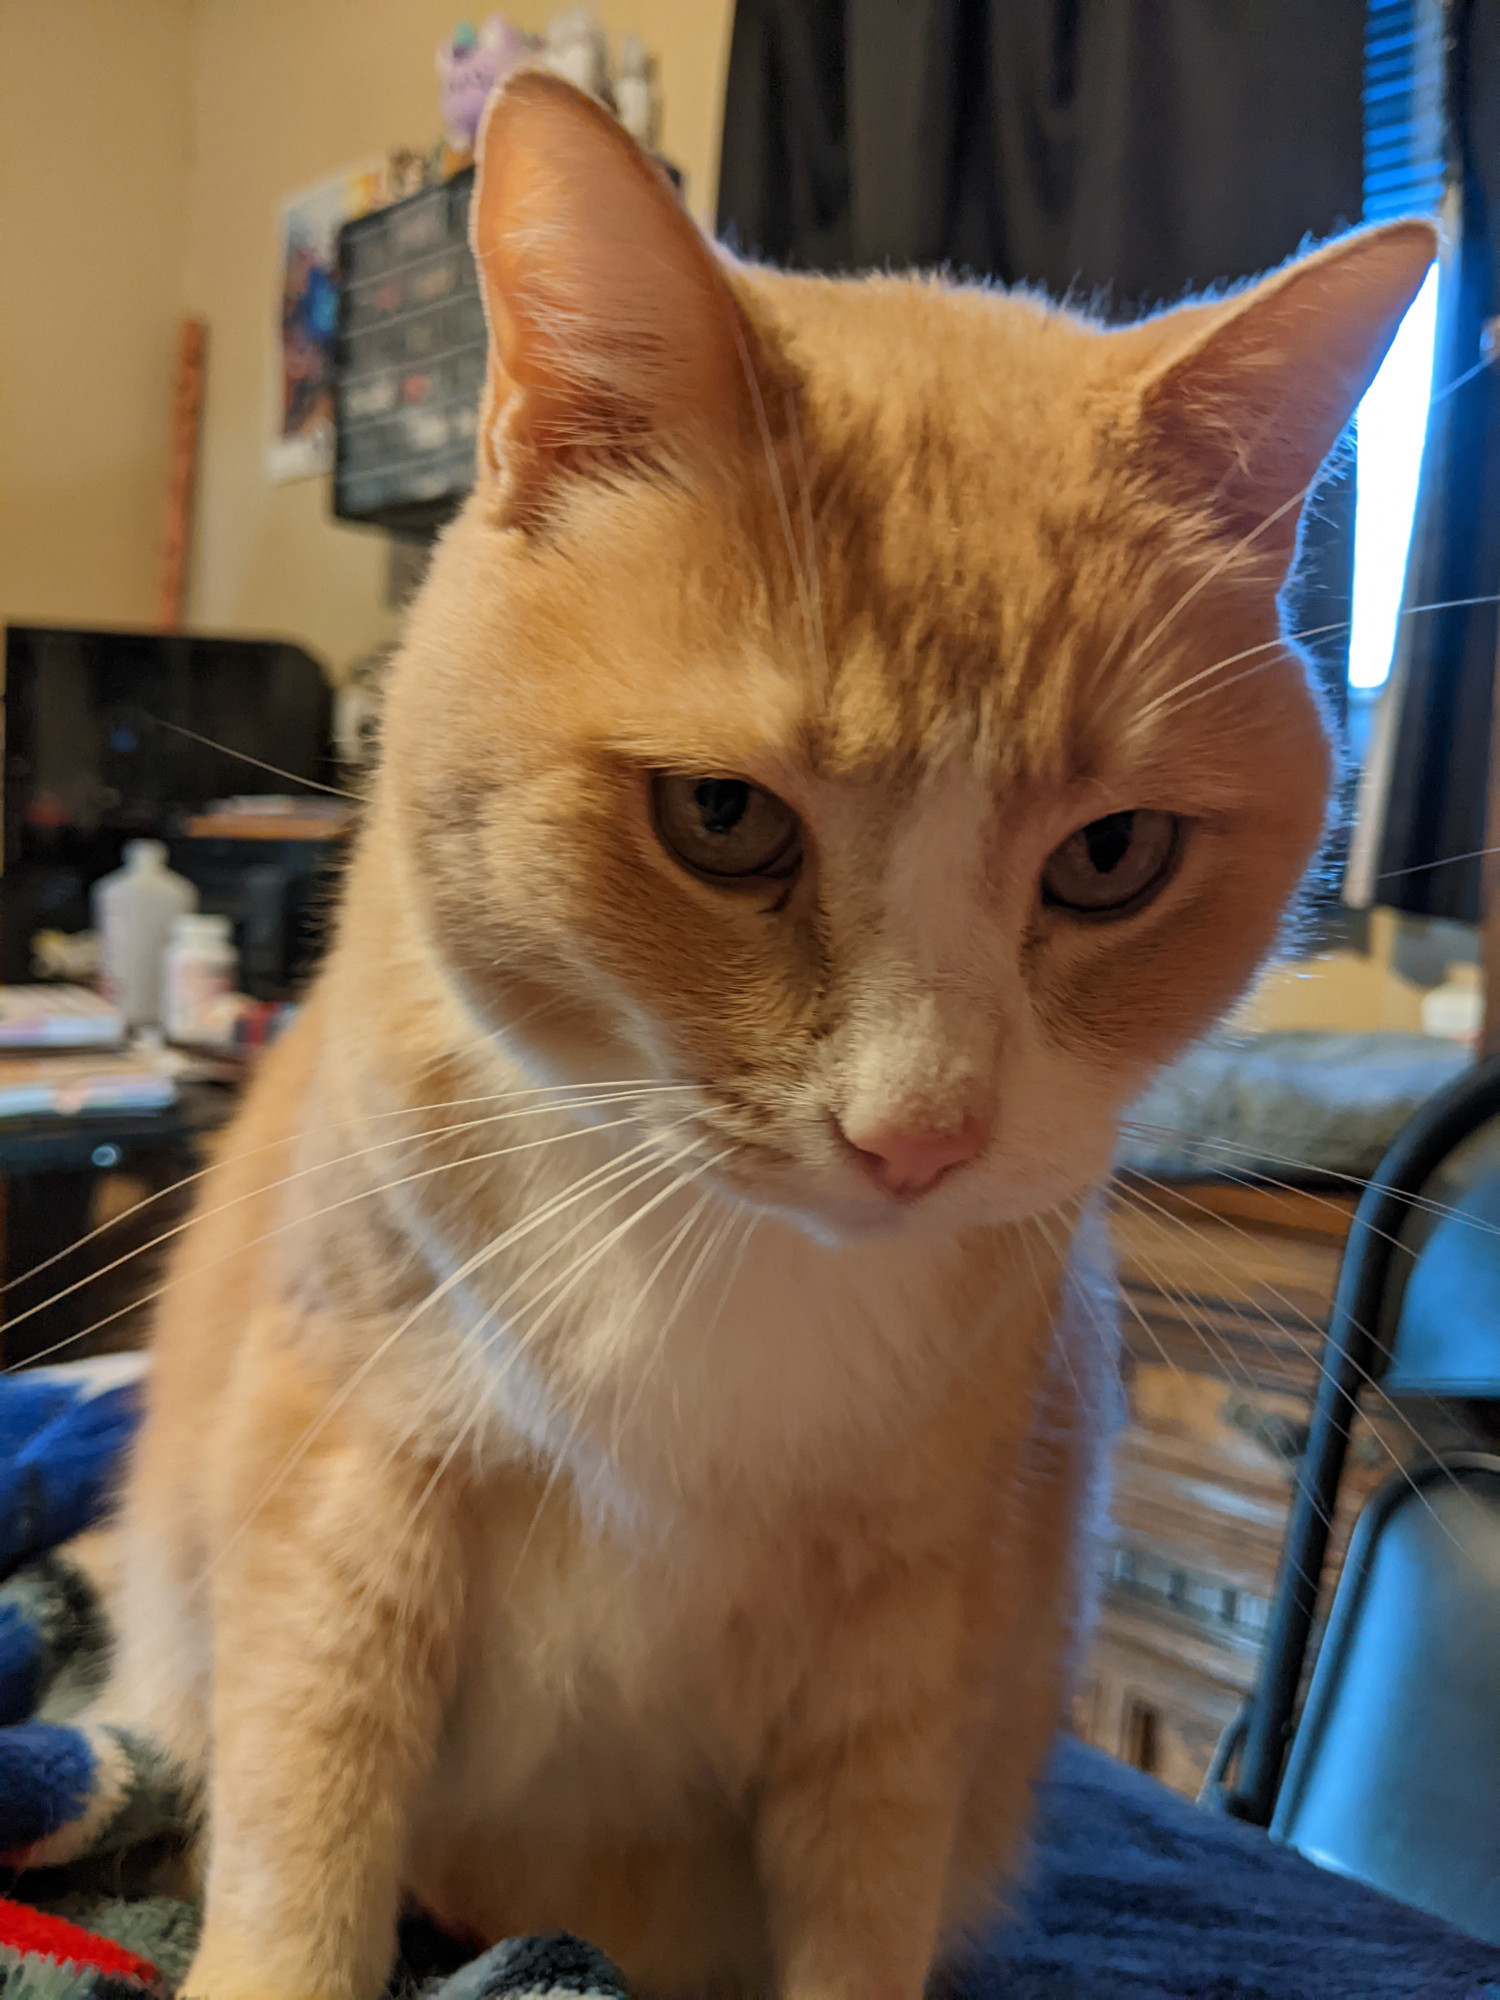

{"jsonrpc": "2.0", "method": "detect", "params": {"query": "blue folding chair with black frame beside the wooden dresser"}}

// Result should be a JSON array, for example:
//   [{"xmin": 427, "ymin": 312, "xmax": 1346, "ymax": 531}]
[{"xmin": 1212, "ymin": 1060, "xmax": 1500, "ymax": 1942}]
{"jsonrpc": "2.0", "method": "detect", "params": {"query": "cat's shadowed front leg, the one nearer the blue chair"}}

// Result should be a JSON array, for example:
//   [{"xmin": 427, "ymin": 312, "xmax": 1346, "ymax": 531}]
[{"xmin": 756, "ymin": 1590, "xmax": 962, "ymax": 2000}]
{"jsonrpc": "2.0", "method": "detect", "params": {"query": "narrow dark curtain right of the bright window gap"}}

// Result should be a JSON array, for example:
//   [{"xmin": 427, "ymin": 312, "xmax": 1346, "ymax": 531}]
[{"xmin": 1372, "ymin": 0, "xmax": 1500, "ymax": 922}]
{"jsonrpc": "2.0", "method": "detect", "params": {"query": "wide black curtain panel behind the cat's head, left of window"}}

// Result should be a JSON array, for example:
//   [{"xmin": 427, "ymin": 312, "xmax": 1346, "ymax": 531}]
[{"xmin": 718, "ymin": 0, "xmax": 1364, "ymax": 714}]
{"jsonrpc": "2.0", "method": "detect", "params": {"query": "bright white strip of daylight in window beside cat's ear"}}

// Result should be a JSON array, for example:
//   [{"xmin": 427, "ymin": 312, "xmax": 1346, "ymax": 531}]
[{"xmin": 1348, "ymin": 264, "xmax": 1438, "ymax": 694}]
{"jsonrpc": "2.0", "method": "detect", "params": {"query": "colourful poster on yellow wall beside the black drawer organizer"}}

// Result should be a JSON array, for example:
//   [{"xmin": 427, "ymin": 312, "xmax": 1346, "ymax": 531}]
[{"xmin": 266, "ymin": 166, "xmax": 384, "ymax": 480}]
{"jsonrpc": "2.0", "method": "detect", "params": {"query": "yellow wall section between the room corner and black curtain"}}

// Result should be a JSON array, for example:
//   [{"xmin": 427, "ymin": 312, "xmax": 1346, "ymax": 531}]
[{"xmin": 184, "ymin": 0, "xmax": 732, "ymax": 672}]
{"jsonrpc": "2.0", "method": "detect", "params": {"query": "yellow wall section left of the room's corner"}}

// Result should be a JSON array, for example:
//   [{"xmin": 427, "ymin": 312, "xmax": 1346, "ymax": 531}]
[{"xmin": 0, "ymin": 0, "xmax": 194, "ymax": 624}]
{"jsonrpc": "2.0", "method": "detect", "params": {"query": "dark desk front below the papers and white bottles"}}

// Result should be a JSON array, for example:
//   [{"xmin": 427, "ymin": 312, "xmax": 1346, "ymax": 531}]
[{"xmin": 0, "ymin": 1084, "xmax": 238, "ymax": 1368}]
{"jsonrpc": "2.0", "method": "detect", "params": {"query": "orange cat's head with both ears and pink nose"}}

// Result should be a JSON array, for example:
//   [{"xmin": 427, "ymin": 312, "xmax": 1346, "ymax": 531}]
[{"xmin": 384, "ymin": 76, "xmax": 1434, "ymax": 1230}]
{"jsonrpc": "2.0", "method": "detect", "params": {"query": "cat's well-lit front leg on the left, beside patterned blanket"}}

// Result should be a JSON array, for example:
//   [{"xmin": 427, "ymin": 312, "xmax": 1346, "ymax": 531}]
[{"xmin": 184, "ymin": 1392, "xmax": 462, "ymax": 2000}]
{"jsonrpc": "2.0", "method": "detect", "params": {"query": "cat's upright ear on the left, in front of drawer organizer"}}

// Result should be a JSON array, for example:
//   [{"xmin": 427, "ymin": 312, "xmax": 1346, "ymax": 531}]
[{"xmin": 470, "ymin": 70, "xmax": 754, "ymax": 524}]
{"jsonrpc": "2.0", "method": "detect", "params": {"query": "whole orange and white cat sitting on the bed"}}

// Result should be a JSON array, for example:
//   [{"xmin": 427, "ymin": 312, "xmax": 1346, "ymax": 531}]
[{"xmin": 67, "ymin": 76, "xmax": 1434, "ymax": 2000}]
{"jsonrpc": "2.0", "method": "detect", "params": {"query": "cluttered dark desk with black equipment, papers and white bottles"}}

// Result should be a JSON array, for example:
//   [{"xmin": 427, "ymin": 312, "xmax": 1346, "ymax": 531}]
[{"xmin": 0, "ymin": 626, "xmax": 354, "ymax": 1366}]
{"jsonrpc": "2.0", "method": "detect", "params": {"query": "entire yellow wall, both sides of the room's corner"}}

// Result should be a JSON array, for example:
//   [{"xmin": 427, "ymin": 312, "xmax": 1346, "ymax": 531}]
[{"xmin": 0, "ymin": 0, "xmax": 732, "ymax": 670}]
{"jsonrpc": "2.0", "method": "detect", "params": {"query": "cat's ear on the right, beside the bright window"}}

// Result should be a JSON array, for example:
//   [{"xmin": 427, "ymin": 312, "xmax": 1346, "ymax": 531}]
[{"xmin": 1124, "ymin": 220, "xmax": 1438, "ymax": 568}]
